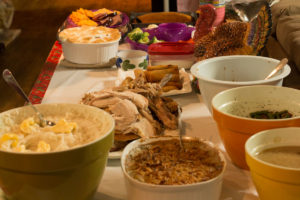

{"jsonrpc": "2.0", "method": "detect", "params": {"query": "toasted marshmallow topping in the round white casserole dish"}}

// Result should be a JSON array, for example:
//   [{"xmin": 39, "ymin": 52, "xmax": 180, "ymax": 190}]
[{"xmin": 59, "ymin": 26, "xmax": 121, "ymax": 43}]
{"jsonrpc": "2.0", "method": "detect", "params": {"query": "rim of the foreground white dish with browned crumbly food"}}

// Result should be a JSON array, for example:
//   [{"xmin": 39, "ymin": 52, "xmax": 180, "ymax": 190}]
[{"xmin": 121, "ymin": 136, "xmax": 227, "ymax": 190}]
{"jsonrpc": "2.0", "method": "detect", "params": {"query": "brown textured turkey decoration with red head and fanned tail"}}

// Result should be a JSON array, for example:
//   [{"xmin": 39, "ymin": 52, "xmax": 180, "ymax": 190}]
[{"xmin": 193, "ymin": 2, "xmax": 272, "ymax": 60}]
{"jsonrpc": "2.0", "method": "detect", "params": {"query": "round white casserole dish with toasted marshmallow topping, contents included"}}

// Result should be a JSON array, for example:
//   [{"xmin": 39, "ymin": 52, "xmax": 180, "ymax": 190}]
[{"xmin": 59, "ymin": 27, "xmax": 121, "ymax": 65}]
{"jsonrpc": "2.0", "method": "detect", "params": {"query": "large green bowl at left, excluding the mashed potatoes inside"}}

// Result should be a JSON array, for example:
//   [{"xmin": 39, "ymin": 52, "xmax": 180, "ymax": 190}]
[{"xmin": 0, "ymin": 104, "xmax": 115, "ymax": 200}]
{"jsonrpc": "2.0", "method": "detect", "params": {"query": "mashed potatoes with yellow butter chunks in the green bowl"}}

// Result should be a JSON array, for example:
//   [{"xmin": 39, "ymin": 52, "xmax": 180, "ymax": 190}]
[{"xmin": 0, "ymin": 115, "xmax": 107, "ymax": 152}]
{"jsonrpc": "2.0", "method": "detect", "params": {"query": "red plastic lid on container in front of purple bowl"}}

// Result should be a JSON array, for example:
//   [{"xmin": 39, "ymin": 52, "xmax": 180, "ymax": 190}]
[{"xmin": 148, "ymin": 42, "xmax": 194, "ymax": 55}]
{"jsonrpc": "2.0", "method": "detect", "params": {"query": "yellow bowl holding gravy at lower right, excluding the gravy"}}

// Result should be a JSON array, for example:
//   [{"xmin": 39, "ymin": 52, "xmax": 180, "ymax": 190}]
[{"xmin": 245, "ymin": 127, "xmax": 300, "ymax": 200}]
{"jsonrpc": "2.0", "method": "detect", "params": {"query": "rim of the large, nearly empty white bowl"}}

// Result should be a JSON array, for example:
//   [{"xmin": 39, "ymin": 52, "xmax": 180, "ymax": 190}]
[{"xmin": 191, "ymin": 55, "xmax": 291, "ymax": 86}]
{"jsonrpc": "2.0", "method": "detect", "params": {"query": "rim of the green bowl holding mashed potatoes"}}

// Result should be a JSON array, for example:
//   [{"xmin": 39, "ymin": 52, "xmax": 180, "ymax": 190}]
[{"xmin": 0, "ymin": 103, "xmax": 115, "ymax": 156}]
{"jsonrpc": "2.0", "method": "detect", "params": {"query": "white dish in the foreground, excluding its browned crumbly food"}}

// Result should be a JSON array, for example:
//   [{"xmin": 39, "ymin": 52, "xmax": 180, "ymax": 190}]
[{"xmin": 121, "ymin": 137, "xmax": 226, "ymax": 200}]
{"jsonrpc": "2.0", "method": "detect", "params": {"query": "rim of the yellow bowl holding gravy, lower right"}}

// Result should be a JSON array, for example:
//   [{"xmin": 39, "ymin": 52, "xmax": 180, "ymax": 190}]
[{"xmin": 245, "ymin": 127, "xmax": 300, "ymax": 172}]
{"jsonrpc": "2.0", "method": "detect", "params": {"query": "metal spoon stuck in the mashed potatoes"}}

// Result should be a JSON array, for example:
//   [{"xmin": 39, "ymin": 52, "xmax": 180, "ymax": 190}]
[{"xmin": 2, "ymin": 69, "xmax": 55, "ymax": 127}]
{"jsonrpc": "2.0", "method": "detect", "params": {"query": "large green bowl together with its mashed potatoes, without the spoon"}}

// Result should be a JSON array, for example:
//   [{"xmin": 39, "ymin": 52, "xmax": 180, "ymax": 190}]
[{"xmin": 0, "ymin": 104, "xmax": 115, "ymax": 200}]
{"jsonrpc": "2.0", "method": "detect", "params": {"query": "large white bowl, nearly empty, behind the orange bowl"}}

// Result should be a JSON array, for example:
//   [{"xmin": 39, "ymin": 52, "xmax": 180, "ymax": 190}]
[{"xmin": 191, "ymin": 55, "xmax": 291, "ymax": 112}]
